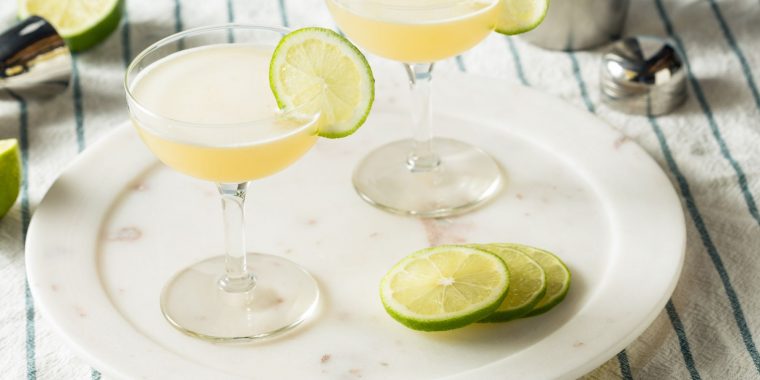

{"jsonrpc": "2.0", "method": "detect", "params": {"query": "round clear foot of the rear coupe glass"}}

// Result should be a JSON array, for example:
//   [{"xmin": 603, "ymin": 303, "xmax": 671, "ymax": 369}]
[{"xmin": 353, "ymin": 138, "xmax": 503, "ymax": 218}]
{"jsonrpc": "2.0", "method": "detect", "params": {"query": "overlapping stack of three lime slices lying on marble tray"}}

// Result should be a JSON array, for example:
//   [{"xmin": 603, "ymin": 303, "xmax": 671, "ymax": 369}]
[{"xmin": 380, "ymin": 243, "xmax": 570, "ymax": 331}]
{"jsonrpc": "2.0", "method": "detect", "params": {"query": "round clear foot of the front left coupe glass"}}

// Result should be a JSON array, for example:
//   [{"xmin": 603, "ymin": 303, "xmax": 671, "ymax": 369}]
[{"xmin": 161, "ymin": 253, "xmax": 319, "ymax": 342}]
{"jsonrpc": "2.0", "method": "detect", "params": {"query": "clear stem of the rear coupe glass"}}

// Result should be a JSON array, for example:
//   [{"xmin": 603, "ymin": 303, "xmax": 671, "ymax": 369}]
[{"xmin": 404, "ymin": 63, "xmax": 441, "ymax": 172}]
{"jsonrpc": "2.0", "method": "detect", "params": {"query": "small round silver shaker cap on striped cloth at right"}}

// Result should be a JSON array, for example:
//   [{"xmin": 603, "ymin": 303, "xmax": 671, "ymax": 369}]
[{"xmin": 599, "ymin": 36, "xmax": 687, "ymax": 115}]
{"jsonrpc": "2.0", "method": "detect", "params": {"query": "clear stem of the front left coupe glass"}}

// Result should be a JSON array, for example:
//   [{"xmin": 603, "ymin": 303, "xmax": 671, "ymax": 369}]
[{"xmin": 217, "ymin": 182, "xmax": 256, "ymax": 293}]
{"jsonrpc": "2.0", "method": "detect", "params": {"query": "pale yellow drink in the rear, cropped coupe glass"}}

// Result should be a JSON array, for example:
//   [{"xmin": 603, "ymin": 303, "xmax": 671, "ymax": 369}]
[{"xmin": 326, "ymin": 0, "xmax": 500, "ymax": 63}]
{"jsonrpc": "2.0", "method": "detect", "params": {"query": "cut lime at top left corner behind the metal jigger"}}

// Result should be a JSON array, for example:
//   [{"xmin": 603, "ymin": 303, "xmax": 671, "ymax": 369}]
[{"xmin": 19, "ymin": 0, "xmax": 124, "ymax": 52}]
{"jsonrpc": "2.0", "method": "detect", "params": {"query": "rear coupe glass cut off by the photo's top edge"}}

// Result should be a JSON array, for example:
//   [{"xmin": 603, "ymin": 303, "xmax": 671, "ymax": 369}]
[{"xmin": 326, "ymin": 0, "xmax": 503, "ymax": 217}]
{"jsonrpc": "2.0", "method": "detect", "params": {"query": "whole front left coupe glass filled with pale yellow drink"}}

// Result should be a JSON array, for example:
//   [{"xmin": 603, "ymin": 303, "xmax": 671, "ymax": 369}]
[{"xmin": 124, "ymin": 24, "xmax": 319, "ymax": 341}]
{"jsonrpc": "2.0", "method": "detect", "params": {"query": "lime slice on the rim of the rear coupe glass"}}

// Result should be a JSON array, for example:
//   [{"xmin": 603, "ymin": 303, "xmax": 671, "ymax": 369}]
[{"xmin": 496, "ymin": 0, "xmax": 548, "ymax": 35}]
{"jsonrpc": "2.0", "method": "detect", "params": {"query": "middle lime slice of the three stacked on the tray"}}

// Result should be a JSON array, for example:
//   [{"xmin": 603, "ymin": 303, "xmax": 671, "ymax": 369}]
[{"xmin": 475, "ymin": 244, "xmax": 546, "ymax": 322}]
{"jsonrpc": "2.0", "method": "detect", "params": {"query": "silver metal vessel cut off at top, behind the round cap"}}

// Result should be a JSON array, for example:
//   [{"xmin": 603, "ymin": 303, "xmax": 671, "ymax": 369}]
[{"xmin": 520, "ymin": 0, "xmax": 629, "ymax": 51}]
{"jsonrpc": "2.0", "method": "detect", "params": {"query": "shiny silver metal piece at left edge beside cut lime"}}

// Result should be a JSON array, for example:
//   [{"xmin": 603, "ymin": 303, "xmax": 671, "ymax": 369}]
[{"xmin": 0, "ymin": 16, "xmax": 71, "ymax": 99}]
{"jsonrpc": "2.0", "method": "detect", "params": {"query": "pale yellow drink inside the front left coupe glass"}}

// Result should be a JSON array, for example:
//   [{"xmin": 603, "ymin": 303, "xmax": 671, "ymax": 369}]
[{"xmin": 131, "ymin": 44, "xmax": 317, "ymax": 183}]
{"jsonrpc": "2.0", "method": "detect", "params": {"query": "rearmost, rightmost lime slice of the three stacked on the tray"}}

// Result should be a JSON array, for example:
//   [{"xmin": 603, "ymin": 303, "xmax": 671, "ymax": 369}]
[{"xmin": 497, "ymin": 243, "xmax": 571, "ymax": 317}]
